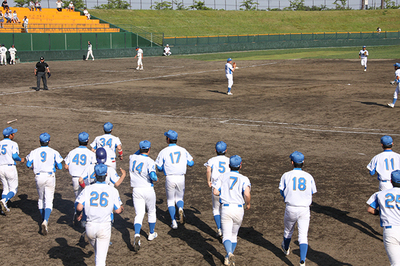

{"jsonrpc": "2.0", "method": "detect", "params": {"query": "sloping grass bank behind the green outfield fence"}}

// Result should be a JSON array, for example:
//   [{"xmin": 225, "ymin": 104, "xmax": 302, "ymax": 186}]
[{"xmin": 90, "ymin": 9, "xmax": 400, "ymax": 37}]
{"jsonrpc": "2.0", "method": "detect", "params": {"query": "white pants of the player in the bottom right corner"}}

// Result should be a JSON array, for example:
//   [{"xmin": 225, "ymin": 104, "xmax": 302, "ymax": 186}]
[{"xmin": 383, "ymin": 226, "xmax": 400, "ymax": 266}]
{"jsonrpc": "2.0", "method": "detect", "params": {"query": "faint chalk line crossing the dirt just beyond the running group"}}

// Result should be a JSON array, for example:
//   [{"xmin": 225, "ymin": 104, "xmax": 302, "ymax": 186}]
[{"xmin": 0, "ymin": 104, "xmax": 400, "ymax": 136}]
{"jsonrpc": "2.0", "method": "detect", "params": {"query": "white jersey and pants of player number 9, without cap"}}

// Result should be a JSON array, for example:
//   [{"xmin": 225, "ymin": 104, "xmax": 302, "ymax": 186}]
[{"xmin": 26, "ymin": 146, "xmax": 63, "ymax": 210}]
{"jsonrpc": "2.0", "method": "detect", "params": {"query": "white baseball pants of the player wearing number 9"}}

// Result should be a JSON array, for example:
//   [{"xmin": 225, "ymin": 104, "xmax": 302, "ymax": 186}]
[{"xmin": 35, "ymin": 173, "xmax": 56, "ymax": 210}]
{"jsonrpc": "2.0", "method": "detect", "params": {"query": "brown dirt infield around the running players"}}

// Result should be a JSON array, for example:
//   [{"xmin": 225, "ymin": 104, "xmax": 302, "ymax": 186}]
[{"xmin": 0, "ymin": 57, "xmax": 400, "ymax": 265}]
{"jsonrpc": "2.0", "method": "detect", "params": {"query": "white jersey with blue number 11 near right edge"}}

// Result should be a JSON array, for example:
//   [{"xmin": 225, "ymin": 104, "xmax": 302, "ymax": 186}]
[{"xmin": 367, "ymin": 150, "xmax": 400, "ymax": 181}]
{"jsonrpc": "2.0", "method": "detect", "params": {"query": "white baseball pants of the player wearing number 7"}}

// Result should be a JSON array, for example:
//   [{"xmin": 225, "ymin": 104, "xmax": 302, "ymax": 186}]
[{"xmin": 221, "ymin": 204, "xmax": 244, "ymax": 243}]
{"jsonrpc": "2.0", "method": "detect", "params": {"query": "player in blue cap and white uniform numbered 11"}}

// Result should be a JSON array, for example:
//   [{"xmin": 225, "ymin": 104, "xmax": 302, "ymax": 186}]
[{"xmin": 367, "ymin": 136, "xmax": 400, "ymax": 191}]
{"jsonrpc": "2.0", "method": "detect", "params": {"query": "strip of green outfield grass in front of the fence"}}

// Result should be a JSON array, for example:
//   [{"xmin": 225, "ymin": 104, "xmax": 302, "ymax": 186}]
[{"xmin": 172, "ymin": 45, "xmax": 400, "ymax": 62}]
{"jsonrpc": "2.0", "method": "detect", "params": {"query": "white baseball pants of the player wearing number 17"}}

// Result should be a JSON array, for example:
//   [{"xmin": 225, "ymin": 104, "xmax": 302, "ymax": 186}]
[{"xmin": 165, "ymin": 175, "xmax": 185, "ymax": 207}]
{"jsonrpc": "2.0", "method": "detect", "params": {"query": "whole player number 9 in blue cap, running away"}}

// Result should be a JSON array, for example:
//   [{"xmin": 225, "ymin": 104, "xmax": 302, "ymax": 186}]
[{"xmin": 26, "ymin": 132, "xmax": 63, "ymax": 235}]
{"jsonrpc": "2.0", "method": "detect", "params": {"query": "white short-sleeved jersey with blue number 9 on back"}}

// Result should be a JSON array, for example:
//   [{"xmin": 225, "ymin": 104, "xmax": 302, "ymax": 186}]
[{"xmin": 26, "ymin": 146, "xmax": 63, "ymax": 174}]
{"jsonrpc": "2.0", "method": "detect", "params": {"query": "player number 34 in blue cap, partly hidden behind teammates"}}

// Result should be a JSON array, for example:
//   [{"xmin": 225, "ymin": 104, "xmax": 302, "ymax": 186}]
[{"xmin": 90, "ymin": 122, "xmax": 123, "ymax": 170}]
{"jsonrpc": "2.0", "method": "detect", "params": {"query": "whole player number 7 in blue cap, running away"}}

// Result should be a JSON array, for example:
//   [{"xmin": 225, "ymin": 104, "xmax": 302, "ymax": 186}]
[{"xmin": 212, "ymin": 155, "xmax": 251, "ymax": 265}]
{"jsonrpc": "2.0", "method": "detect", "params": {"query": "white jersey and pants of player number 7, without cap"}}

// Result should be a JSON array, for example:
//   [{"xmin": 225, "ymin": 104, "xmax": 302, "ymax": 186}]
[{"xmin": 212, "ymin": 171, "xmax": 251, "ymax": 243}]
